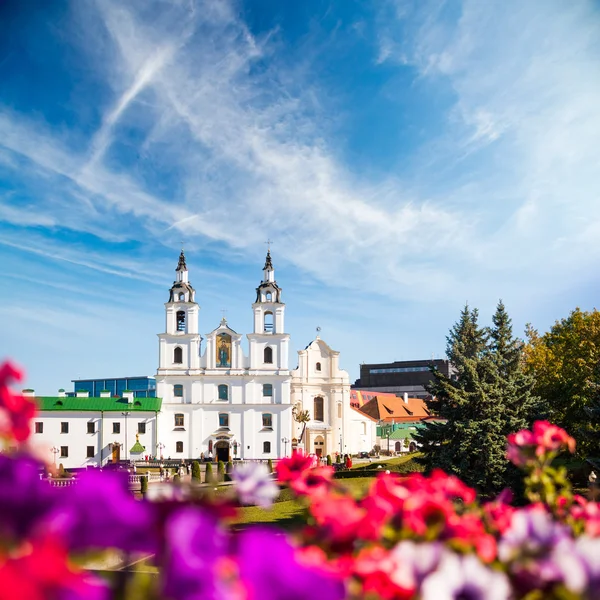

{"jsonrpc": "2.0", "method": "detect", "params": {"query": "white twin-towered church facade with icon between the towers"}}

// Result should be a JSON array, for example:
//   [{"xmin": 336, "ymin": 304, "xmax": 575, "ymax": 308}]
[{"xmin": 156, "ymin": 251, "xmax": 293, "ymax": 460}]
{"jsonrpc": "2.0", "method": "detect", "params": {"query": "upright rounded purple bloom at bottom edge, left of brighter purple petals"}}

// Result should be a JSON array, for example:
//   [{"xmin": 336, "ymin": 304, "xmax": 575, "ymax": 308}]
[{"xmin": 162, "ymin": 506, "xmax": 233, "ymax": 600}]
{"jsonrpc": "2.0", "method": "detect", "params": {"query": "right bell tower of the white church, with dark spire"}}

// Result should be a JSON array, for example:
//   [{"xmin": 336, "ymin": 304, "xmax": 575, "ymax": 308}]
[{"xmin": 248, "ymin": 249, "xmax": 289, "ymax": 370}]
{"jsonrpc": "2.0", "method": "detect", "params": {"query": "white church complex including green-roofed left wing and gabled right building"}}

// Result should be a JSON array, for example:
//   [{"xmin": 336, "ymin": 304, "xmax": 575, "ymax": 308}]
[{"xmin": 32, "ymin": 251, "xmax": 375, "ymax": 468}]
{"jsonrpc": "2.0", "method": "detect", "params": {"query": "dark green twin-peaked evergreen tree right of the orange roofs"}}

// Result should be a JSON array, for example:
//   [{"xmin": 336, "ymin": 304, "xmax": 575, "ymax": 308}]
[{"xmin": 414, "ymin": 302, "xmax": 537, "ymax": 494}]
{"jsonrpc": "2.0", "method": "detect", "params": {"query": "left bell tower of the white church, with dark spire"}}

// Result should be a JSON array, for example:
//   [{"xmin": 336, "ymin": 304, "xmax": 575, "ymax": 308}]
[{"xmin": 158, "ymin": 250, "xmax": 200, "ymax": 375}]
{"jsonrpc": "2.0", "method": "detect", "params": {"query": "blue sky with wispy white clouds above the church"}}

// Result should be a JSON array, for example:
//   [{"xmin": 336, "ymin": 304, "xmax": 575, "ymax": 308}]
[{"xmin": 0, "ymin": 0, "xmax": 600, "ymax": 394}]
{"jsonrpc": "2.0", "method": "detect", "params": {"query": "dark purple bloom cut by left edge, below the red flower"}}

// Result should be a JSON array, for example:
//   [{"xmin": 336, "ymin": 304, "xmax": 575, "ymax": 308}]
[{"xmin": 0, "ymin": 455, "xmax": 57, "ymax": 540}]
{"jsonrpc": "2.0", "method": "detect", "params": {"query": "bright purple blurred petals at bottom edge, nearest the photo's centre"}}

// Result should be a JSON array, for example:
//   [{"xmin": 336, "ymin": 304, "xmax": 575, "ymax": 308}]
[{"xmin": 238, "ymin": 529, "xmax": 345, "ymax": 600}]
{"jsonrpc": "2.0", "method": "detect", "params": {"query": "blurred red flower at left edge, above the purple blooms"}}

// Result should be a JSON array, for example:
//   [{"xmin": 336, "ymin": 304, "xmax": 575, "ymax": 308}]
[{"xmin": 0, "ymin": 362, "xmax": 37, "ymax": 442}]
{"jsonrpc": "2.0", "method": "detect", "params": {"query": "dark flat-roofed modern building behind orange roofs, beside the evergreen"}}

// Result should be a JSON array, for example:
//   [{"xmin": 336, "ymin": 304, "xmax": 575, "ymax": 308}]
[{"xmin": 352, "ymin": 359, "xmax": 454, "ymax": 398}]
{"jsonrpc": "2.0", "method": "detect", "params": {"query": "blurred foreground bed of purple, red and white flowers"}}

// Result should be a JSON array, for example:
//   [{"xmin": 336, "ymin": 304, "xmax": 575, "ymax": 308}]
[{"xmin": 0, "ymin": 364, "xmax": 600, "ymax": 600}]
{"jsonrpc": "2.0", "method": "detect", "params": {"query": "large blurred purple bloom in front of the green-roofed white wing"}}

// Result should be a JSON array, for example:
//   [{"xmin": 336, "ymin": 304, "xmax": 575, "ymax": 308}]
[{"xmin": 49, "ymin": 471, "xmax": 156, "ymax": 552}]
